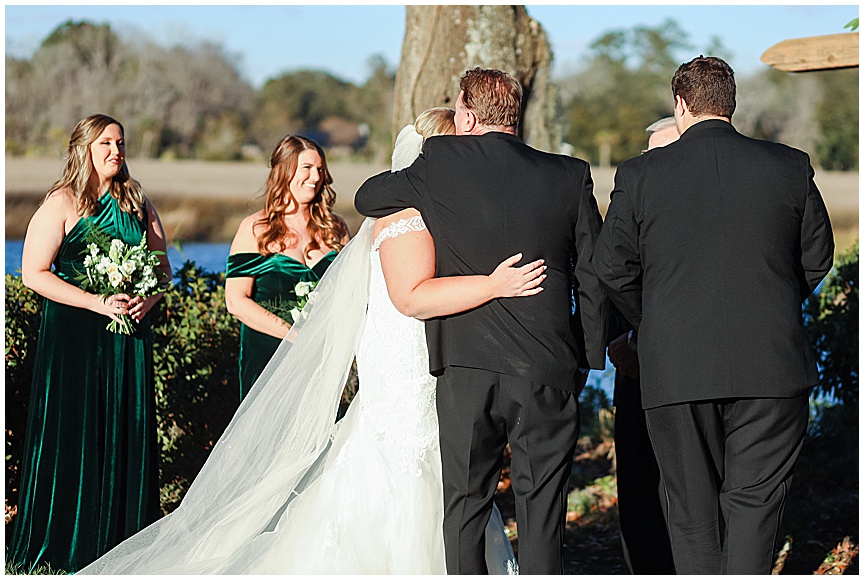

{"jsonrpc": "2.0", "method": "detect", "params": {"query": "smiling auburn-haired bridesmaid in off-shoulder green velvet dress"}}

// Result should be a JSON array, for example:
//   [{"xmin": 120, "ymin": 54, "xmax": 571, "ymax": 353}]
[{"xmin": 225, "ymin": 135, "xmax": 349, "ymax": 400}]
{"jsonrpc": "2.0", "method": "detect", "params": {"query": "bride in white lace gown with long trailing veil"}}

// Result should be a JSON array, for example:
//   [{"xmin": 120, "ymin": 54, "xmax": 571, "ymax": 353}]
[{"xmin": 79, "ymin": 111, "xmax": 543, "ymax": 574}]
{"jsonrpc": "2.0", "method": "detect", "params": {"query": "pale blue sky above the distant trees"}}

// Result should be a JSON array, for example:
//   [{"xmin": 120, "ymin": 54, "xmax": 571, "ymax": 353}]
[{"xmin": 5, "ymin": 3, "xmax": 858, "ymax": 87}]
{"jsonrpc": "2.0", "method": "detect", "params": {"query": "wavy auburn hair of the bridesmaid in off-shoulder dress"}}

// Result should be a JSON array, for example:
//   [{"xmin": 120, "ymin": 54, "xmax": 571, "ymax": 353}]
[{"xmin": 255, "ymin": 135, "xmax": 348, "ymax": 258}]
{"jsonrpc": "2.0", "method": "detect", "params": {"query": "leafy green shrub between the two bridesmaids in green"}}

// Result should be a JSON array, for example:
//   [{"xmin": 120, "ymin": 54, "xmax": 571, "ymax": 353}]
[{"xmin": 152, "ymin": 261, "xmax": 240, "ymax": 513}]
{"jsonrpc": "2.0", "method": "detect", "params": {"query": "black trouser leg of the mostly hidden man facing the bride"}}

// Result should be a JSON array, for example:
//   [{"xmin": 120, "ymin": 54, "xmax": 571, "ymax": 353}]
[{"xmin": 615, "ymin": 372, "xmax": 675, "ymax": 574}]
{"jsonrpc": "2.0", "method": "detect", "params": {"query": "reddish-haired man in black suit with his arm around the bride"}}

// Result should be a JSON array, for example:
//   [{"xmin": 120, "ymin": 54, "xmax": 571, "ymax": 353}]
[{"xmin": 354, "ymin": 68, "xmax": 606, "ymax": 574}]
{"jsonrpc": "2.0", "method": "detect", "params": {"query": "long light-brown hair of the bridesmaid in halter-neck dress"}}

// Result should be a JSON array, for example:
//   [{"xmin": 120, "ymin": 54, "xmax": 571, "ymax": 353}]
[{"xmin": 42, "ymin": 114, "xmax": 146, "ymax": 219}]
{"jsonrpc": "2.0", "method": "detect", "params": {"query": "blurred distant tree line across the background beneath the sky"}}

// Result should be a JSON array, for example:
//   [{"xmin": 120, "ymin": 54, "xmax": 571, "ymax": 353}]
[{"xmin": 6, "ymin": 20, "xmax": 859, "ymax": 170}]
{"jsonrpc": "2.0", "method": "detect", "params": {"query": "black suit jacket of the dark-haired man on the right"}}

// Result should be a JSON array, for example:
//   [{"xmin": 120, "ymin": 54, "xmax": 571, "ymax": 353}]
[{"xmin": 593, "ymin": 119, "xmax": 834, "ymax": 409}]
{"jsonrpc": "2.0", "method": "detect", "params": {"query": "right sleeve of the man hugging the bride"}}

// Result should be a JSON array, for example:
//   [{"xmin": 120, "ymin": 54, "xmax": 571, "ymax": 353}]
[{"xmin": 574, "ymin": 163, "xmax": 609, "ymax": 369}]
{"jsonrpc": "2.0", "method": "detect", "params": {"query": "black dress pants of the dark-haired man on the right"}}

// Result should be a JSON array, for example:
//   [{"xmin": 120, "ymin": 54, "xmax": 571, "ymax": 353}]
[{"xmin": 646, "ymin": 393, "xmax": 809, "ymax": 574}]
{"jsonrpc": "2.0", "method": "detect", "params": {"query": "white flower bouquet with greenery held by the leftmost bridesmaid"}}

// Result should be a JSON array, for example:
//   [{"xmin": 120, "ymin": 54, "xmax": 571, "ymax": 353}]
[{"xmin": 75, "ymin": 223, "xmax": 168, "ymax": 334}]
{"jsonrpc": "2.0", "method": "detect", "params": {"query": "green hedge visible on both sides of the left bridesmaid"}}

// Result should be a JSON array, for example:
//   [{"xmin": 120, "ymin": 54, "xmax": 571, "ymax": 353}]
[{"xmin": 5, "ymin": 262, "xmax": 240, "ymax": 513}]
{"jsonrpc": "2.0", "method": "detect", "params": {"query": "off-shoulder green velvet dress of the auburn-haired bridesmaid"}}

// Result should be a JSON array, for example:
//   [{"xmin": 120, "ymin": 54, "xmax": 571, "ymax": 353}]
[{"xmin": 225, "ymin": 250, "xmax": 336, "ymax": 400}]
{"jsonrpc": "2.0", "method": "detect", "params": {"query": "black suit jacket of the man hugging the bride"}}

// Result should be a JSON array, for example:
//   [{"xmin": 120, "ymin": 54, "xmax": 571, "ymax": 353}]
[{"xmin": 354, "ymin": 132, "xmax": 607, "ymax": 391}]
